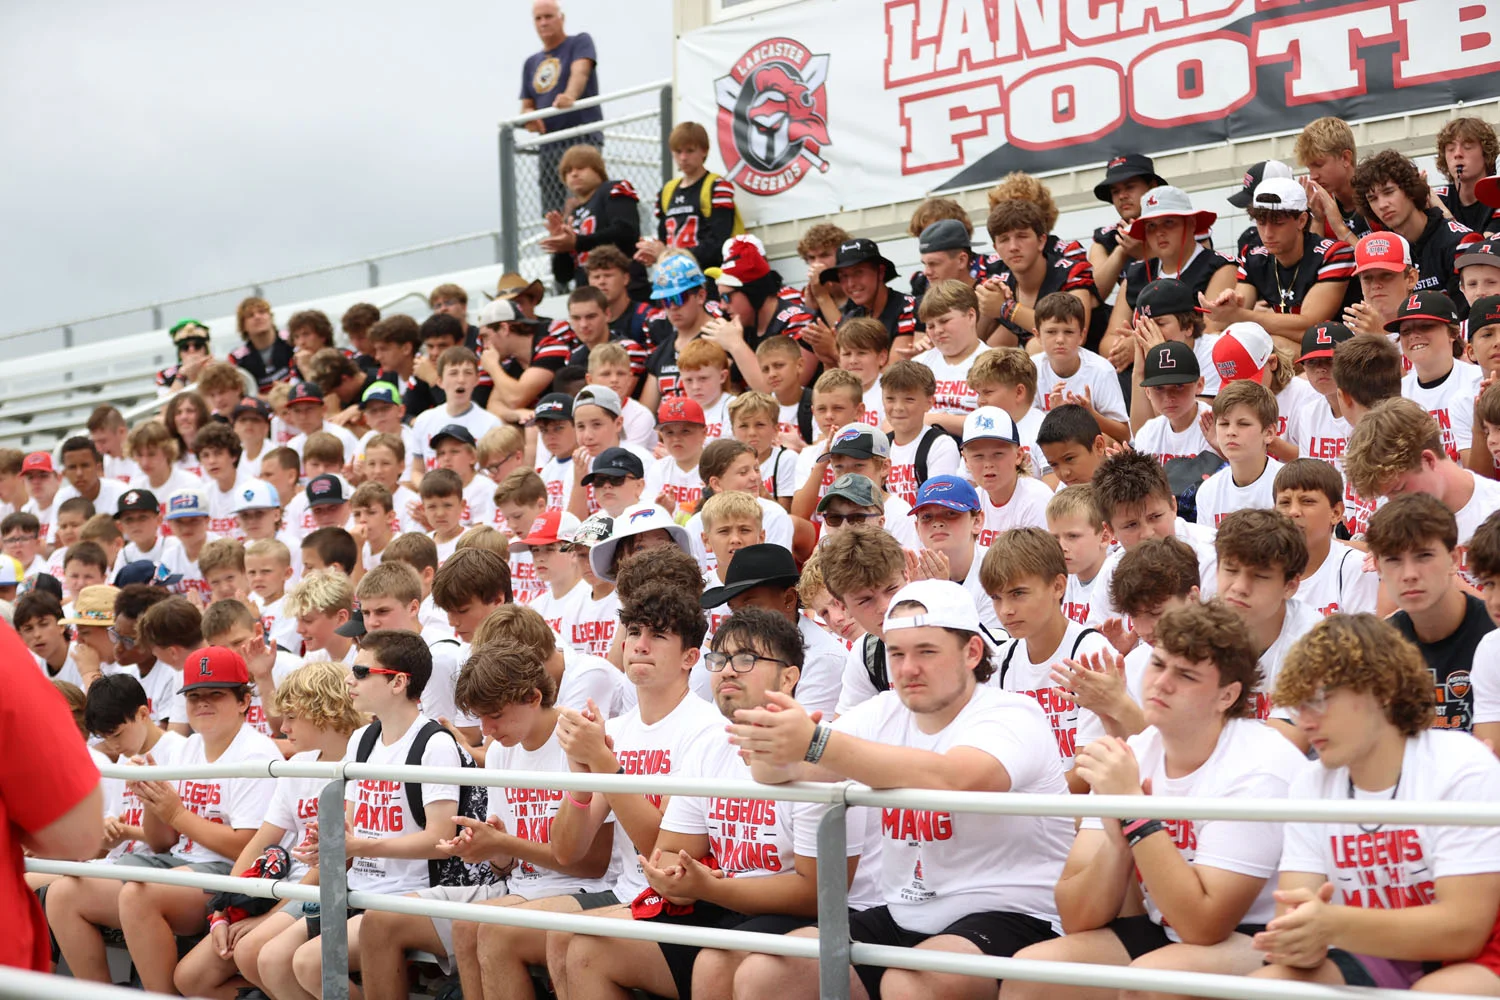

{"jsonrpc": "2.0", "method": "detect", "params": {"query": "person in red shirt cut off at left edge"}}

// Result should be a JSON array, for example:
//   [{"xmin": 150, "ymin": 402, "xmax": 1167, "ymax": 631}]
[{"xmin": 0, "ymin": 628, "xmax": 104, "ymax": 972}]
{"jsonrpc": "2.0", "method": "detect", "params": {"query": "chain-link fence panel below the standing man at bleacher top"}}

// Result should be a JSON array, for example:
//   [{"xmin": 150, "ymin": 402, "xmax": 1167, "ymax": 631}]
[{"xmin": 501, "ymin": 111, "xmax": 672, "ymax": 291}]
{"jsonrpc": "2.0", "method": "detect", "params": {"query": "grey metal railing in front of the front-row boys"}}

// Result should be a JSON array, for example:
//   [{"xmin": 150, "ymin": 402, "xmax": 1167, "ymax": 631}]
[{"xmin": 23, "ymin": 762, "xmax": 1500, "ymax": 1000}]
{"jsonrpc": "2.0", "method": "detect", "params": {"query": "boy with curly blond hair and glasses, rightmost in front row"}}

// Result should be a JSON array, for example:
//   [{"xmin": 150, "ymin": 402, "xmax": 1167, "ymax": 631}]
[{"xmin": 1251, "ymin": 614, "xmax": 1500, "ymax": 996}]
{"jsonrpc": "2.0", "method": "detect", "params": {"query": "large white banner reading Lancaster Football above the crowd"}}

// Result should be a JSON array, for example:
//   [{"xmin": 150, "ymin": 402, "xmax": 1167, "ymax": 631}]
[{"xmin": 677, "ymin": 0, "xmax": 1500, "ymax": 223}]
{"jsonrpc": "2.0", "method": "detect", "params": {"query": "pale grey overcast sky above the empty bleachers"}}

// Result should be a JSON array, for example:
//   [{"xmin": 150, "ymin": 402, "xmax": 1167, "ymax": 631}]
[{"xmin": 0, "ymin": 0, "xmax": 672, "ymax": 331}]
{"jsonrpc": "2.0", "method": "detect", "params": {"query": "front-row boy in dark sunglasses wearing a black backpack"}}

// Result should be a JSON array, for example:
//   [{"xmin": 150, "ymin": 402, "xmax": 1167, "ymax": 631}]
[{"xmin": 260, "ymin": 630, "xmax": 504, "ymax": 999}]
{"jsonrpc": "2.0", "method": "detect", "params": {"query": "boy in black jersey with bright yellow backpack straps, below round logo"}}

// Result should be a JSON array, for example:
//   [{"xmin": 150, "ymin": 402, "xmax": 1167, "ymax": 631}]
[{"xmin": 636, "ymin": 121, "xmax": 746, "ymax": 268}]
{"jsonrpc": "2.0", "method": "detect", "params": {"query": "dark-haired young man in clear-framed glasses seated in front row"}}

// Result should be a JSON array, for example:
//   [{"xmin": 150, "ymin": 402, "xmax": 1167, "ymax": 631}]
[{"xmin": 567, "ymin": 607, "xmax": 879, "ymax": 997}]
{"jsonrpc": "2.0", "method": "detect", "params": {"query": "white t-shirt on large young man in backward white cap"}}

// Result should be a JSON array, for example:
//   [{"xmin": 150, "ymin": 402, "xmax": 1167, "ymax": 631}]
[{"xmin": 834, "ymin": 692, "xmax": 1073, "ymax": 934}]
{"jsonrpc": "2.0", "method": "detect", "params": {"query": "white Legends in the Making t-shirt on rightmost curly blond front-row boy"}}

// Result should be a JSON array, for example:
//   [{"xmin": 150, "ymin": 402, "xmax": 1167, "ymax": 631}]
[{"xmin": 1281, "ymin": 729, "xmax": 1500, "ymax": 910}]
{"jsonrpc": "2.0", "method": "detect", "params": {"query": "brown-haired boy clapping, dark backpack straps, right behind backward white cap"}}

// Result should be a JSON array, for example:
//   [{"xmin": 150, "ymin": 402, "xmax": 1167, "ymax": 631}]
[{"xmin": 980, "ymin": 528, "xmax": 1110, "ymax": 793}]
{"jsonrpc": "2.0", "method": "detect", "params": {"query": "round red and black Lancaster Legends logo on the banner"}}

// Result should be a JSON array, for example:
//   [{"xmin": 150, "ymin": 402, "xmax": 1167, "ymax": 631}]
[{"xmin": 714, "ymin": 37, "xmax": 831, "ymax": 195}]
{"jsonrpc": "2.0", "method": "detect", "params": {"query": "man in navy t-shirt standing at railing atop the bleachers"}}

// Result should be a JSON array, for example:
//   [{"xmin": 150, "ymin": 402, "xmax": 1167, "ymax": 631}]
[{"xmin": 521, "ymin": 0, "xmax": 605, "ymax": 214}]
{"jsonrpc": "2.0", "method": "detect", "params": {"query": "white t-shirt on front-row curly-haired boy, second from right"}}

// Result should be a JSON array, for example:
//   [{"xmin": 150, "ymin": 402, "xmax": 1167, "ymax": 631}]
[{"xmin": 1083, "ymin": 718, "xmax": 1307, "ymax": 942}]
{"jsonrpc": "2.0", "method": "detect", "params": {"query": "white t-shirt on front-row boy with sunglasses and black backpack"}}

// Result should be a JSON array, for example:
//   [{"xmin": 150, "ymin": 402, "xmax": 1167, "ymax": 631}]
[{"xmin": 344, "ymin": 715, "xmax": 459, "ymax": 894}]
